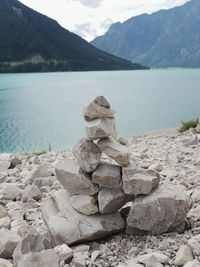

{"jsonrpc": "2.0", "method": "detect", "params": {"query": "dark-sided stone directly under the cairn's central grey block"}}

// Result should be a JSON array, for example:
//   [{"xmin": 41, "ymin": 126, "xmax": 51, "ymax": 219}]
[{"xmin": 98, "ymin": 186, "xmax": 126, "ymax": 214}]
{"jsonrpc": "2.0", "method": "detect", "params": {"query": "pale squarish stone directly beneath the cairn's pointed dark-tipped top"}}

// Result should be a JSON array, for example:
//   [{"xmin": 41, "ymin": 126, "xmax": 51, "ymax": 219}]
[{"xmin": 85, "ymin": 118, "xmax": 116, "ymax": 140}]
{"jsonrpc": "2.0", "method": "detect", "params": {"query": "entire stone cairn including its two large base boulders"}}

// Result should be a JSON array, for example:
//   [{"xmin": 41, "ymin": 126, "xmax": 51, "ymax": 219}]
[{"xmin": 42, "ymin": 96, "xmax": 191, "ymax": 247}]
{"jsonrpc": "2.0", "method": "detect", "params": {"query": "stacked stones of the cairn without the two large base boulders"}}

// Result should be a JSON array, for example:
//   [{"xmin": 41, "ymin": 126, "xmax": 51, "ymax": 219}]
[{"xmin": 56, "ymin": 96, "xmax": 159, "ymax": 216}]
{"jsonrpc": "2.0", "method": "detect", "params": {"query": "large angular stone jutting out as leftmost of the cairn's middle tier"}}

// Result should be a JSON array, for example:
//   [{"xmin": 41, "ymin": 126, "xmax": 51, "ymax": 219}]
[{"xmin": 55, "ymin": 160, "xmax": 99, "ymax": 195}]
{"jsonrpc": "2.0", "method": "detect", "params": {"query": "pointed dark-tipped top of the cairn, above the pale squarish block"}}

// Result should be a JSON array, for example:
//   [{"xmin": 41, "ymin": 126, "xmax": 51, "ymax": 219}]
[{"xmin": 83, "ymin": 97, "xmax": 115, "ymax": 121}]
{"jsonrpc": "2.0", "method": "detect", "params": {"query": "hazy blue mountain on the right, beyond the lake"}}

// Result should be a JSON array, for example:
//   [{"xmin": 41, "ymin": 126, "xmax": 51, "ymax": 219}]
[{"xmin": 92, "ymin": 0, "xmax": 200, "ymax": 67}]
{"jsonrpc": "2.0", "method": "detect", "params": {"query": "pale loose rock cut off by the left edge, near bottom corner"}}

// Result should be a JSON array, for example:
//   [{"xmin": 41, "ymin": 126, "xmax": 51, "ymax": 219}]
[{"xmin": 0, "ymin": 228, "xmax": 21, "ymax": 259}]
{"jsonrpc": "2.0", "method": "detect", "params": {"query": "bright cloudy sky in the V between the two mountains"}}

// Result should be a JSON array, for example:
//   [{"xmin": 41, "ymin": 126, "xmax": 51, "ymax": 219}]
[{"xmin": 20, "ymin": 0, "xmax": 189, "ymax": 41}]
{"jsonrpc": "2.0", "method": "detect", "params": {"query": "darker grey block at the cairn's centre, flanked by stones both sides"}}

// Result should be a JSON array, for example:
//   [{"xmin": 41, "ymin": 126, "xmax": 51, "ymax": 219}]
[{"xmin": 92, "ymin": 163, "xmax": 121, "ymax": 187}]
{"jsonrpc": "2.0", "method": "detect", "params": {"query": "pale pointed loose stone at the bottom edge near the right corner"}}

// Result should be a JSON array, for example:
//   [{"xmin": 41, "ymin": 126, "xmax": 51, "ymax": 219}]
[{"xmin": 174, "ymin": 245, "xmax": 194, "ymax": 266}]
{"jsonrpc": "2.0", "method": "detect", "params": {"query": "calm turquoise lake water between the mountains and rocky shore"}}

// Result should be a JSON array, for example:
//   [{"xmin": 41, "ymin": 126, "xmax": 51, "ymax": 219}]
[{"xmin": 0, "ymin": 69, "xmax": 200, "ymax": 152}]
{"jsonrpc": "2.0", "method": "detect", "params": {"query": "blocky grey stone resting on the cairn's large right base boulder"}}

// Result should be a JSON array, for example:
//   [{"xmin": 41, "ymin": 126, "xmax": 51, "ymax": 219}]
[{"xmin": 122, "ymin": 170, "xmax": 160, "ymax": 196}]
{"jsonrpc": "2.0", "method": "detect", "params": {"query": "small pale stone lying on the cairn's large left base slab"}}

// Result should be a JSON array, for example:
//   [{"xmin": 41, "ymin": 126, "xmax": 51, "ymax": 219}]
[{"xmin": 70, "ymin": 195, "xmax": 99, "ymax": 215}]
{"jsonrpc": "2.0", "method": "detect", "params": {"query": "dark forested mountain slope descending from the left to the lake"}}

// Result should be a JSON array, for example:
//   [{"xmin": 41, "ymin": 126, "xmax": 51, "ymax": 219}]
[{"xmin": 0, "ymin": 0, "xmax": 147, "ymax": 72}]
